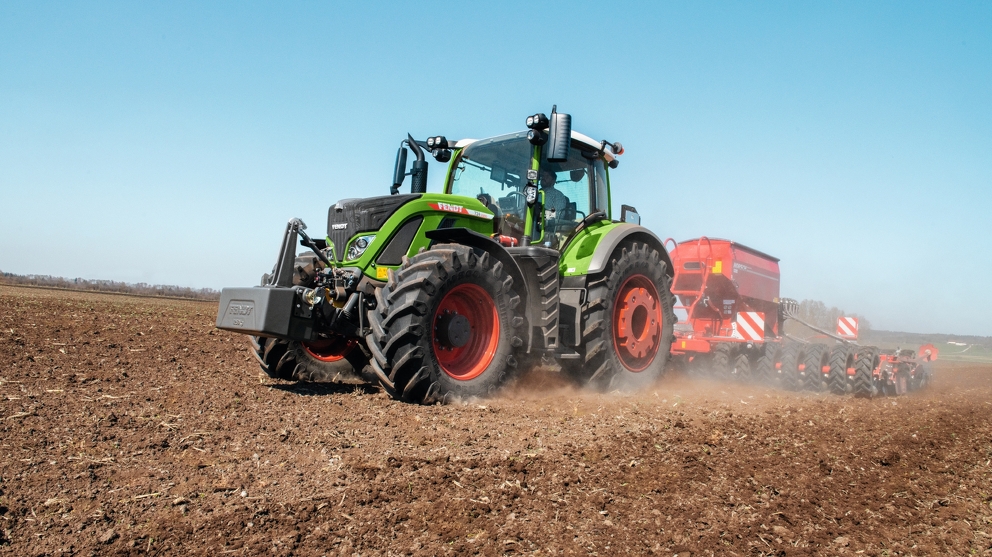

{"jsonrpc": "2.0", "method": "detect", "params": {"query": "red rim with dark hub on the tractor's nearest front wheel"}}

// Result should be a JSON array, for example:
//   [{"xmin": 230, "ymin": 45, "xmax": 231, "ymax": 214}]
[{"xmin": 431, "ymin": 283, "xmax": 500, "ymax": 381}]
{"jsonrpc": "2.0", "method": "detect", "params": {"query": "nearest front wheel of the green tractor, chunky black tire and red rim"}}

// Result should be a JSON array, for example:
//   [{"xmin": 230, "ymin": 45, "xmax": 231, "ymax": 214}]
[{"xmin": 367, "ymin": 244, "xmax": 524, "ymax": 404}]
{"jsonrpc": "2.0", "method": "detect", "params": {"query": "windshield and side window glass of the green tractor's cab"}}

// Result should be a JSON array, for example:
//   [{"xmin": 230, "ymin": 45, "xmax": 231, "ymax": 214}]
[{"xmin": 448, "ymin": 132, "xmax": 609, "ymax": 245}]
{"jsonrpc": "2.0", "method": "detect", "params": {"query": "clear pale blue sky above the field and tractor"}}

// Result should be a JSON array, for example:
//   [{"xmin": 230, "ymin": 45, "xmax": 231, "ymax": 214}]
[{"xmin": 0, "ymin": 1, "xmax": 992, "ymax": 335}]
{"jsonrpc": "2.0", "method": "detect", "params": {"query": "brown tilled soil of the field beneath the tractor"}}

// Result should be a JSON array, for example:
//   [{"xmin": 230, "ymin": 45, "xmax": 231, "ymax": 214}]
[{"xmin": 0, "ymin": 287, "xmax": 992, "ymax": 557}]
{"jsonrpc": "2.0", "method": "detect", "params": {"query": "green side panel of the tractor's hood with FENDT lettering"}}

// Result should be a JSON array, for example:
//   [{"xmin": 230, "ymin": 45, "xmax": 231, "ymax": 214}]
[{"xmin": 339, "ymin": 193, "xmax": 493, "ymax": 280}]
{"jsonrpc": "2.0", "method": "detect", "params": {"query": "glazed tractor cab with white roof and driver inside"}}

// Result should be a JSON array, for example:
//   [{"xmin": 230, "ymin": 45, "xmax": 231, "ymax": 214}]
[{"xmin": 444, "ymin": 132, "xmax": 614, "ymax": 249}]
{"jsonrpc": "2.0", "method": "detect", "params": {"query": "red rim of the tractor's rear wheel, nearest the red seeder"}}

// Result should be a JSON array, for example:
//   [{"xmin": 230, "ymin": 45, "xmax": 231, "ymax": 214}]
[{"xmin": 613, "ymin": 275, "xmax": 664, "ymax": 372}]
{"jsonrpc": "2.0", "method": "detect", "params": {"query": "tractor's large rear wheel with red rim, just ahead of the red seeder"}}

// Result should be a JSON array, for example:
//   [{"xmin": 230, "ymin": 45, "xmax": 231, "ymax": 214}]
[{"xmin": 562, "ymin": 242, "xmax": 675, "ymax": 391}]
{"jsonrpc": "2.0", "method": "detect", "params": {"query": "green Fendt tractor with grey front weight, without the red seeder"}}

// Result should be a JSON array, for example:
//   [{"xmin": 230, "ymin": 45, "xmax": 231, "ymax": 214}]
[{"xmin": 217, "ymin": 109, "xmax": 675, "ymax": 403}]
